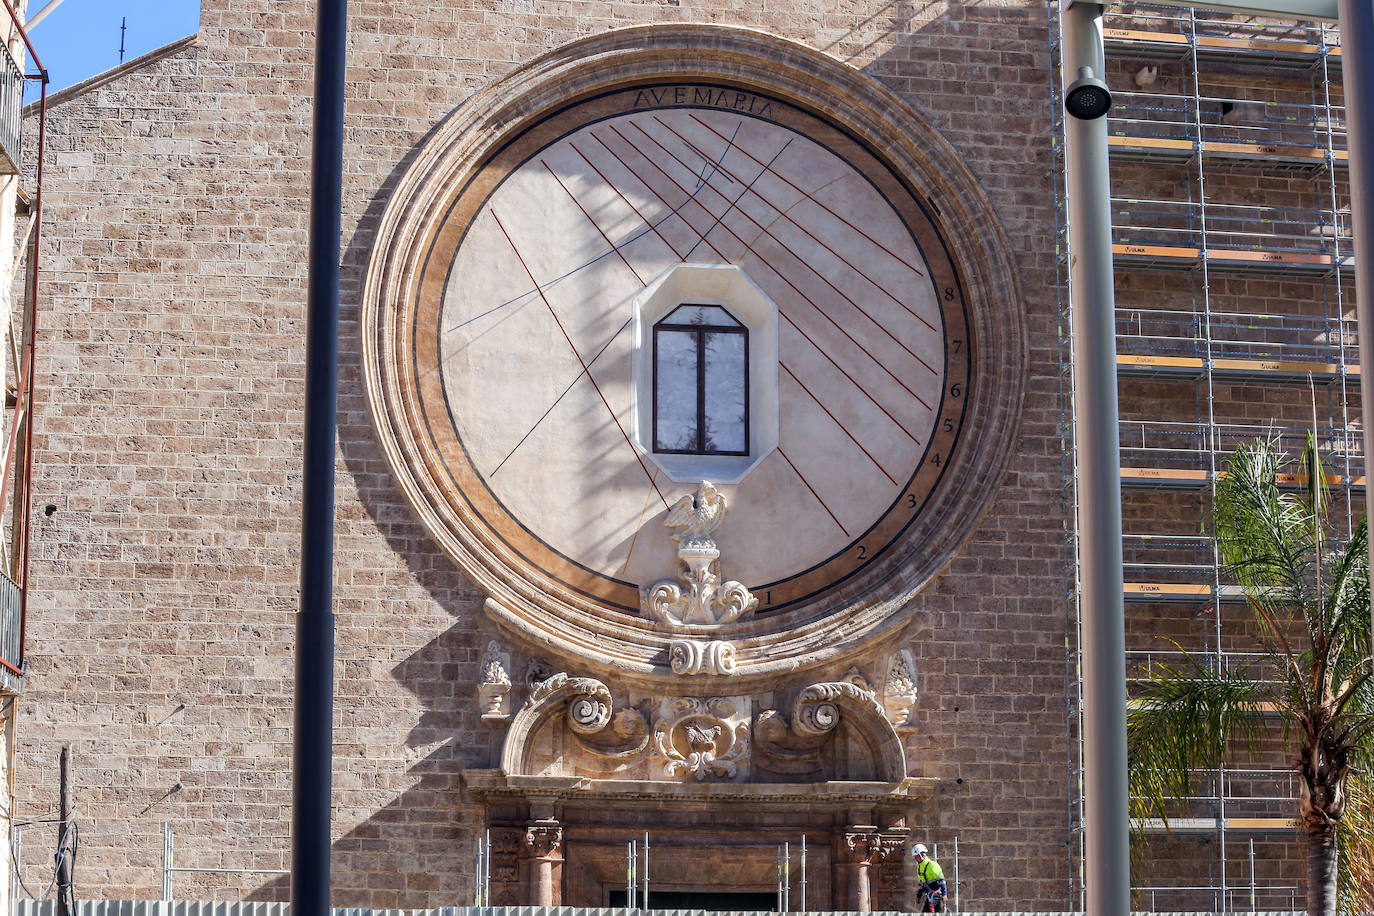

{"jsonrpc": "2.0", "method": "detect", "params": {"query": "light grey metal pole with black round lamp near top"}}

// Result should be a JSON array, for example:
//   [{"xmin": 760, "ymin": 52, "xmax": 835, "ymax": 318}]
[{"xmin": 1059, "ymin": 0, "xmax": 1131, "ymax": 916}]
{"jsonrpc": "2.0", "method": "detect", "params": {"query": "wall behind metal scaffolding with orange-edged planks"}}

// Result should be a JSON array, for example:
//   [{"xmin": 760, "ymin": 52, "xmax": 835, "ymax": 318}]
[{"xmin": 1050, "ymin": 4, "xmax": 1366, "ymax": 912}]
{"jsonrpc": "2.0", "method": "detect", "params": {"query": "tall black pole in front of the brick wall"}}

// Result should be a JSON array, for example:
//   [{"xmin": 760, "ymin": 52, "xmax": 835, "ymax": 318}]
[{"xmin": 291, "ymin": 0, "xmax": 348, "ymax": 916}]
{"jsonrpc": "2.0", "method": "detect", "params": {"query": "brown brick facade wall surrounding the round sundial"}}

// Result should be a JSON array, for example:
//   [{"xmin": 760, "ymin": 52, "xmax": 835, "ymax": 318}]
[{"xmin": 18, "ymin": 0, "xmax": 1072, "ymax": 909}]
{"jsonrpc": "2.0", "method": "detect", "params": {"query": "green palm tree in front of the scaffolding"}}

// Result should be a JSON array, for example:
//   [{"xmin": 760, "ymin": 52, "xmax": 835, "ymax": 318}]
[{"xmin": 1127, "ymin": 434, "xmax": 1374, "ymax": 916}]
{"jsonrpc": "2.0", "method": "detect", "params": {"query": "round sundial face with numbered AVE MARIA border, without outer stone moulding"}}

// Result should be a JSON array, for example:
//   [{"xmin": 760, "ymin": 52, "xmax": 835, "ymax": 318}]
[{"xmin": 428, "ymin": 89, "xmax": 969, "ymax": 612}]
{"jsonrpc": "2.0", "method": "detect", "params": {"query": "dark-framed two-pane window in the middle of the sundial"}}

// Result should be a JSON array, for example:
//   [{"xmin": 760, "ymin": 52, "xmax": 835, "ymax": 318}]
[{"xmin": 654, "ymin": 304, "xmax": 749, "ymax": 455}]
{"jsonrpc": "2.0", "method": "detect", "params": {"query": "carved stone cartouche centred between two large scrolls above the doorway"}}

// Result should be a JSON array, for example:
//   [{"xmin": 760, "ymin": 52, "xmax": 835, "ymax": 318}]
[{"xmin": 654, "ymin": 696, "xmax": 750, "ymax": 781}]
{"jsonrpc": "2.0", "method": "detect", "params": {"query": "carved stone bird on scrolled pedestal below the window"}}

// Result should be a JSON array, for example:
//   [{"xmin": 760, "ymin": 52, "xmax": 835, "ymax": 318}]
[{"xmin": 640, "ymin": 481, "xmax": 758, "ymax": 626}]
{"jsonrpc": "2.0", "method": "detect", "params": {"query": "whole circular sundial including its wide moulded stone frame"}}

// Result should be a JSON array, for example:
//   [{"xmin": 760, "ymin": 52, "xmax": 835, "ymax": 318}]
[{"xmin": 363, "ymin": 26, "xmax": 1024, "ymax": 677}]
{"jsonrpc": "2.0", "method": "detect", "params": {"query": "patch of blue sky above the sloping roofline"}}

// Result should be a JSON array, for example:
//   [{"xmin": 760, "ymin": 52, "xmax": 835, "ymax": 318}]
[{"xmin": 29, "ymin": 0, "xmax": 201, "ymax": 92}]
